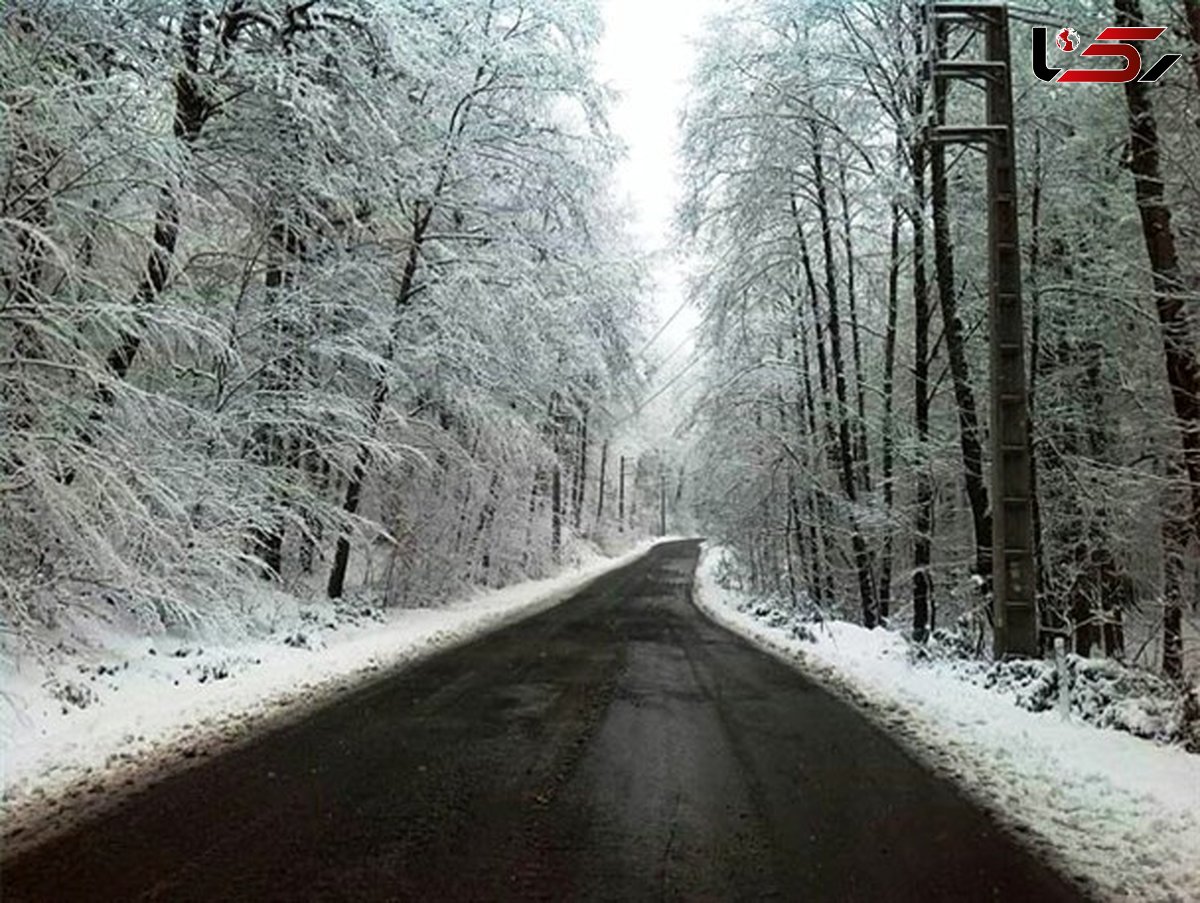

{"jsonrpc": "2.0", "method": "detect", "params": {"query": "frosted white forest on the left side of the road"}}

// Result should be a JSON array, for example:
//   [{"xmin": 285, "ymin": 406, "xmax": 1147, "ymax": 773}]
[{"xmin": 0, "ymin": 0, "xmax": 676, "ymax": 635}]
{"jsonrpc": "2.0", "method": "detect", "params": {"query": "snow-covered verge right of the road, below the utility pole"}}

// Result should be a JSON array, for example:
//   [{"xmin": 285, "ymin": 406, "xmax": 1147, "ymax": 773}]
[{"xmin": 695, "ymin": 549, "xmax": 1200, "ymax": 901}]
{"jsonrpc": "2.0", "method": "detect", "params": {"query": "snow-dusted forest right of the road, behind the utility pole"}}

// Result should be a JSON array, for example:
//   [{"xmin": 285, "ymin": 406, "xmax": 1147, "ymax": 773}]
[{"xmin": 682, "ymin": 0, "xmax": 1200, "ymax": 678}]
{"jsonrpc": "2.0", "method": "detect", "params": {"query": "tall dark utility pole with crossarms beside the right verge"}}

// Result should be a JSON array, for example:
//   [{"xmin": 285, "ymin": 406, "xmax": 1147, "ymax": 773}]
[{"xmin": 925, "ymin": 1, "xmax": 1038, "ymax": 658}]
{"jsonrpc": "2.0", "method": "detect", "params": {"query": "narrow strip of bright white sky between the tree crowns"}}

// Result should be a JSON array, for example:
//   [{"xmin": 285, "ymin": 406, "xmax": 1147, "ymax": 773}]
[{"xmin": 598, "ymin": 0, "xmax": 720, "ymax": 369}]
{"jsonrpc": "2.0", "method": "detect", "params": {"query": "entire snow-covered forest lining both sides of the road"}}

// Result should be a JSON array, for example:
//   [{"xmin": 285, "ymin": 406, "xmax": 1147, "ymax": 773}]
[{"xmin": 0, "ymin": 0, "xmax": 1200, "ymax": 677}]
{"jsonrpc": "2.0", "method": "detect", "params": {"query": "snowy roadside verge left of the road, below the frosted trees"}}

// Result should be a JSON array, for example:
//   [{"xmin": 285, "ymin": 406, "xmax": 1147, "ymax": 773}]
[{"xmin": 0, "ymin": 540, "xmax": 661, "ymax": 855}]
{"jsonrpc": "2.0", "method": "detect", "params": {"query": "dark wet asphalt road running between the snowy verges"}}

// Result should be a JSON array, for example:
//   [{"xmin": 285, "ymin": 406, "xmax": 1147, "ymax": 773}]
[{"xmin": 0, "ymin": 543, "xmax": 1079, "ymax": 903}]
